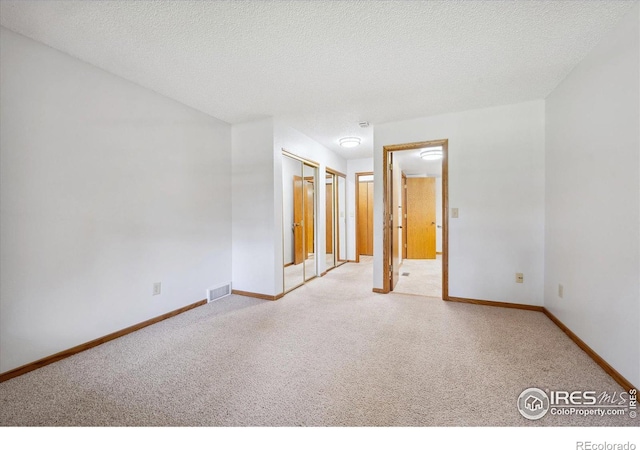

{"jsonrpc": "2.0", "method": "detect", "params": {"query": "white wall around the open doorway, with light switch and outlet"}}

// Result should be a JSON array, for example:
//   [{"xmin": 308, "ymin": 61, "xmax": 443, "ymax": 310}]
[{"xmin": 374, "ymin": 100, "xmax": 544, "ymax": 305}]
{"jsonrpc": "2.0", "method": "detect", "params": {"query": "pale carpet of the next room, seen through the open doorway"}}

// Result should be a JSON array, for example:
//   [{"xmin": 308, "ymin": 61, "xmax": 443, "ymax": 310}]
[{"xmin": 393, "ymin": 255, "xmax": 442, "ymax": 299}]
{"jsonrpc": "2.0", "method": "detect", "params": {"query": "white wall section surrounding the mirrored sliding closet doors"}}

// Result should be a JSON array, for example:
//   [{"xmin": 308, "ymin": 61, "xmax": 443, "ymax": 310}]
[{"xmin": 272, "ymin": 119, "xmax": 347, "ymax": 282}]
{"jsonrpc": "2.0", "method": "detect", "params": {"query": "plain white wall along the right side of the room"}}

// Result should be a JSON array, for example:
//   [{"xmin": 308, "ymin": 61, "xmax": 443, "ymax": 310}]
[{"xmin": 544, "ymin": 6, "xmax": 640, "ymax": 386}]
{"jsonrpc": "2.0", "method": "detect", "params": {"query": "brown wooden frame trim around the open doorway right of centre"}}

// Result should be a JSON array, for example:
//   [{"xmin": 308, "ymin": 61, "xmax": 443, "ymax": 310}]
[{"xmin": 382, "ymin": 139, "xmax": 449, "ymax": 300}]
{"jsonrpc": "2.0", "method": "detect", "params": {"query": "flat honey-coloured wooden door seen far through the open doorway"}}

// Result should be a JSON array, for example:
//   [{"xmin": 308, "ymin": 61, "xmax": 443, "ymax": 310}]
[{"xmin": 406, "ymin": 178, "xmax": 436, "ymax": 259}]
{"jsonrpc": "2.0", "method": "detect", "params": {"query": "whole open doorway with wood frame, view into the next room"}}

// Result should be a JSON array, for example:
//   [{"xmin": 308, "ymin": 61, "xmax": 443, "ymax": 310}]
[{"xmin": 381, "ymin": 139, "xmax": 448, "ymax": 300}]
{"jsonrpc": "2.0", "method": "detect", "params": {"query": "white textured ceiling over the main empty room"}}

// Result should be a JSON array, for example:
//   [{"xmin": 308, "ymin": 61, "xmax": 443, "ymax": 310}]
[{"xmin": 0, "ymin": 0, "xmax": 636, "ymax": 158}]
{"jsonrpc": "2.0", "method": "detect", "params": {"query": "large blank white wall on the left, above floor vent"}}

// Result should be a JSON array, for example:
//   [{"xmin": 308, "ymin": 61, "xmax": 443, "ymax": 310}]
[{"xmin": 0, "ymin": 28, "xmax": 231, "ymax": 372}]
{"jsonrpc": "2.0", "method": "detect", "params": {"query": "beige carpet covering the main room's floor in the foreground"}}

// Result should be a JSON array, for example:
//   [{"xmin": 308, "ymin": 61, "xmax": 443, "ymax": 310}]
[{"xmin": 0, "ymin": 262, "xmax": 638, "ymax": 426}]
